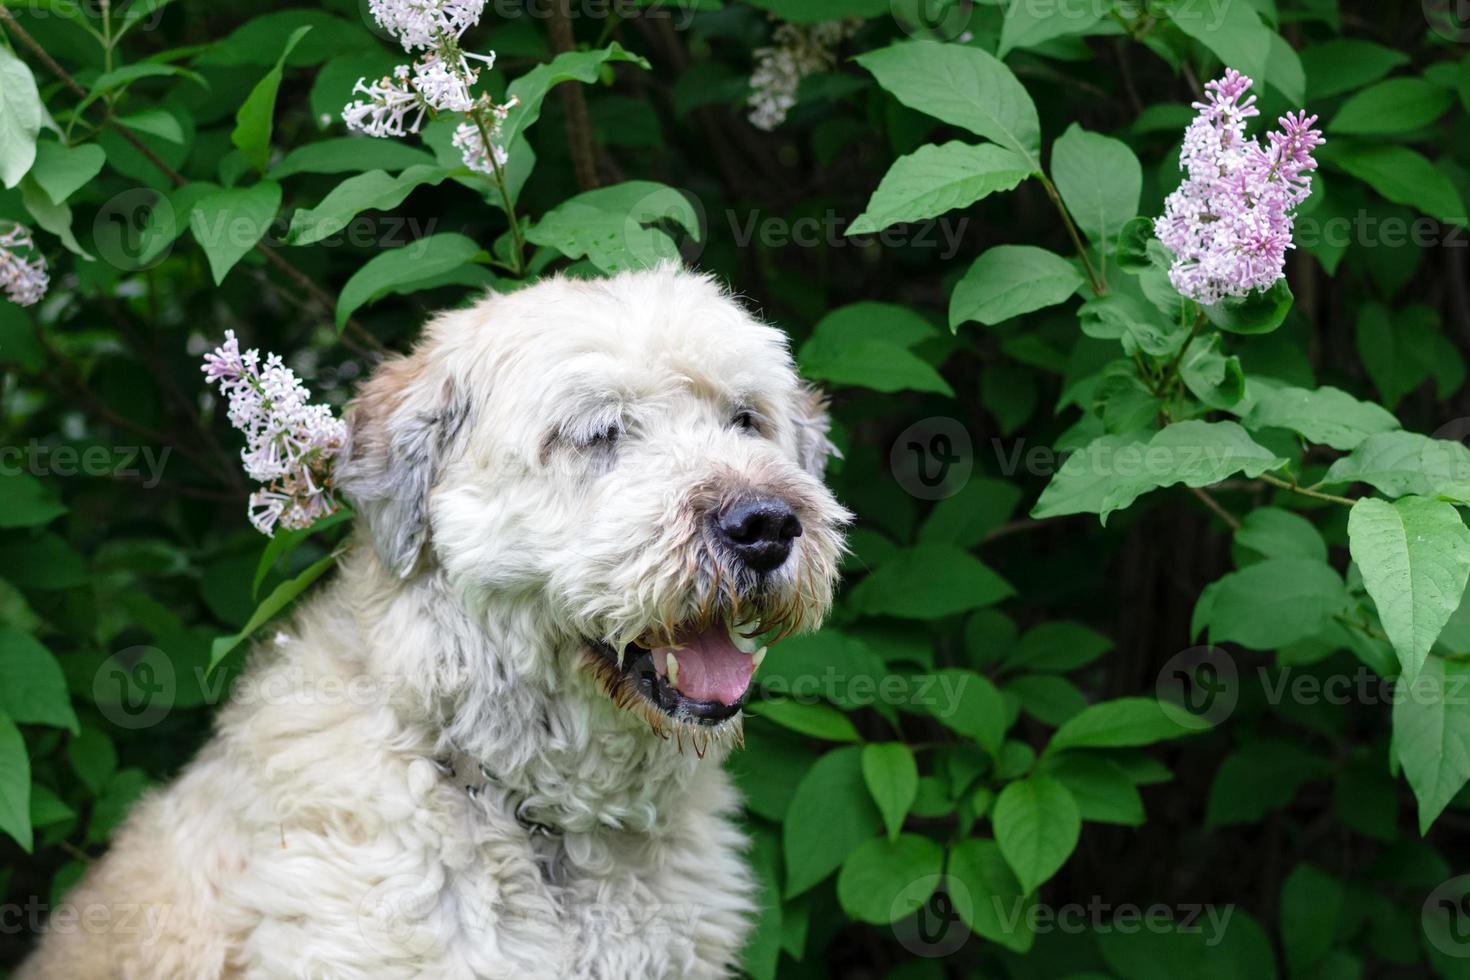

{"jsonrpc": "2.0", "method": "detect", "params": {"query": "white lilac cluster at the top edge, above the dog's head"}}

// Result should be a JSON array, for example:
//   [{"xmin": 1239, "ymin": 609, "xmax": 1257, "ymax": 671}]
[{"xmin": 343, "ymin": 0, "xmax": 515, "ymax": 173}]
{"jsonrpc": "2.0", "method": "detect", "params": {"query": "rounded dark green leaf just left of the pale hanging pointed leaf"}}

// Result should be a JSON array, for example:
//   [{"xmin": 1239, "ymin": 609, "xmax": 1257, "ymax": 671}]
[{"xmin": 1197, "ymin": 558, "xmax": 1351, "ymax": 649}]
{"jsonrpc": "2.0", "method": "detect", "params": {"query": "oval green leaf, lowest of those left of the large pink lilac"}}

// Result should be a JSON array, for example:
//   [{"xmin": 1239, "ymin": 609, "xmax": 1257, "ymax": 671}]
[{"xmin": 950, "ymin": 245, "xmax": 1085, "ymax": 331}]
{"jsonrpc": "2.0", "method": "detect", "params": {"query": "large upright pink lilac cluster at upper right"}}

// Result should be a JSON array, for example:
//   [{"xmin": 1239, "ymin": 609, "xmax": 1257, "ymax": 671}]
[{"xmin": 1154, "ymin": 69, "xmax": 1323, "ymax": 306}]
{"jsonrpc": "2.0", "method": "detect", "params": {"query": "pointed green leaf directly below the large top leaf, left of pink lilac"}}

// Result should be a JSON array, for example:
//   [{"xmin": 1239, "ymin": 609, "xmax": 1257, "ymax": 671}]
[{"xmin": 844, "ymin": 141, "xmax": 1032, "ymax": 235}]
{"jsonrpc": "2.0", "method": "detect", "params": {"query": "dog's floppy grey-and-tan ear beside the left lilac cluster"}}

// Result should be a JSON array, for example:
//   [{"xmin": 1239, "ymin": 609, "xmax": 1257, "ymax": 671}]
[{"xmin": 335, "ymin": 354, "xmax": 466, "ymax": 579}]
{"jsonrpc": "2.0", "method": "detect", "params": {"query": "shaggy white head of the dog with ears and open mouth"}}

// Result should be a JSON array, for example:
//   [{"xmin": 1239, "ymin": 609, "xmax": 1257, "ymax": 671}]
[{"xmin": 337, "ymin": 269, "xmax": 848, "ymax": 730}]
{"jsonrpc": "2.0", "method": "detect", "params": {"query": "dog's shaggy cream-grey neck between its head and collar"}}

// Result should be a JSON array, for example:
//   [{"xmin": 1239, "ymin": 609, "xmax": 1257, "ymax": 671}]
[{"xmin": 341, "ymin": 548, "xmax": 734, "ymax": 833}]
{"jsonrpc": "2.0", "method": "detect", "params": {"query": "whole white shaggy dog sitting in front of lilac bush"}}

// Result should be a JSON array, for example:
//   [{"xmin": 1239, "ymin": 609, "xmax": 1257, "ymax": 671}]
[{"xmin": 18, "ymin": 269, "xmax": 848, "ymax": 980}]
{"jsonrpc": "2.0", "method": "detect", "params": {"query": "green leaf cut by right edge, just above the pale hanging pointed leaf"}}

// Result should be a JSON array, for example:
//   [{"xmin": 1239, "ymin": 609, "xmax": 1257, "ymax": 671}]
[{"xmin": 1322, "ymin": 432, "xmax": 1470, "ymax": 502}]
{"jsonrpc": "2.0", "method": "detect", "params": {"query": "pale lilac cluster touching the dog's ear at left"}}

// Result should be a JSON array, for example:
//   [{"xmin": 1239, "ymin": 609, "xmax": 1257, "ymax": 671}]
[{"xmin": 203, "ymin": 331, "xmax": 347, "ymax": 535}]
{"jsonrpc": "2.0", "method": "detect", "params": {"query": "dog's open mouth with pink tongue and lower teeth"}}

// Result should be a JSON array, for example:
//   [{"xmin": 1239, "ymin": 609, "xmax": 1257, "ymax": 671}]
[{"xmin": 591, "ymin": 620, "xmax": 766, "ymax": 726}]
